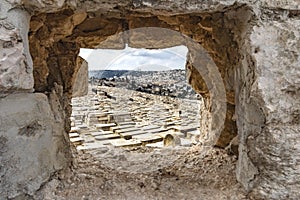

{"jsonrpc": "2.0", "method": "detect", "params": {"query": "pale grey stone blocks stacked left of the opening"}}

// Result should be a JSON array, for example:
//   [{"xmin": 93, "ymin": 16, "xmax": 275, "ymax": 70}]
[{"xmin": 0, "ymin": 1, "xmax": 71, "ymax": 199}]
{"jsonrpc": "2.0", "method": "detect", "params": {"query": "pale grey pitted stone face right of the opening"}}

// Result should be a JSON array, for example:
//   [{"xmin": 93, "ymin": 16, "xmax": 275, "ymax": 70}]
[{"xmin": 238, "ymin": 15, "xmax": 300, "ymax": 199}]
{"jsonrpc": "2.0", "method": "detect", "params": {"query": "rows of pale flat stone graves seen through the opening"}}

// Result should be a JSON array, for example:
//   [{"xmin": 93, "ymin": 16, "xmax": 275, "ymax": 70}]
[{"xmin": 69, "ymin": 86, "xmax": 200, "ymax": 150}]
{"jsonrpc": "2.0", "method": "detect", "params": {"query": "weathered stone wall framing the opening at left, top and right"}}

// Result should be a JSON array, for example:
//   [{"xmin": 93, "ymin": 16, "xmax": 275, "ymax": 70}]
[{"xmin": 0, "ymin": 0, "xmax": 300, "ymax": 199}]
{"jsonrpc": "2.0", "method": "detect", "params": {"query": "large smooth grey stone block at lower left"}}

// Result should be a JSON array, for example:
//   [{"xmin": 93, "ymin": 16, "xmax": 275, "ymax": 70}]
[{"xmin": 0, "ymin": 93, "xmax": 67, "ymax": 198}]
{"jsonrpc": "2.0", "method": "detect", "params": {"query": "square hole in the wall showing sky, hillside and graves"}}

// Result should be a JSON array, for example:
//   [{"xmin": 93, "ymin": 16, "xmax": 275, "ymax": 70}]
[{"xmin": 69, "ymin": 46, "xmax": 201, "ymax": 155}]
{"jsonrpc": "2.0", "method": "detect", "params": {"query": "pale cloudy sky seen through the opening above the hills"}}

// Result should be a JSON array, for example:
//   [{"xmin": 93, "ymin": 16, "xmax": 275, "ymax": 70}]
[{"xmin": 79, "ymin": 46, "xmax": 188, "ymax": 71}]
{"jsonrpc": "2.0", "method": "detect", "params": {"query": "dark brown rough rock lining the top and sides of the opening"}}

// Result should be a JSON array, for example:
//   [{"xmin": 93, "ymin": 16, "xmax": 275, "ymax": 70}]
[{"xmin": 29, "ymin": 5, "xmax": 246, "ymax": 195}]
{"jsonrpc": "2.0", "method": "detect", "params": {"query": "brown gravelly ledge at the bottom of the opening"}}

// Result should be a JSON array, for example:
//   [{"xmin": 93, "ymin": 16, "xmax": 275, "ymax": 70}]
[{"xmin": 35, "ymin": 146, "xmax": 247, "ymax": 200}]
